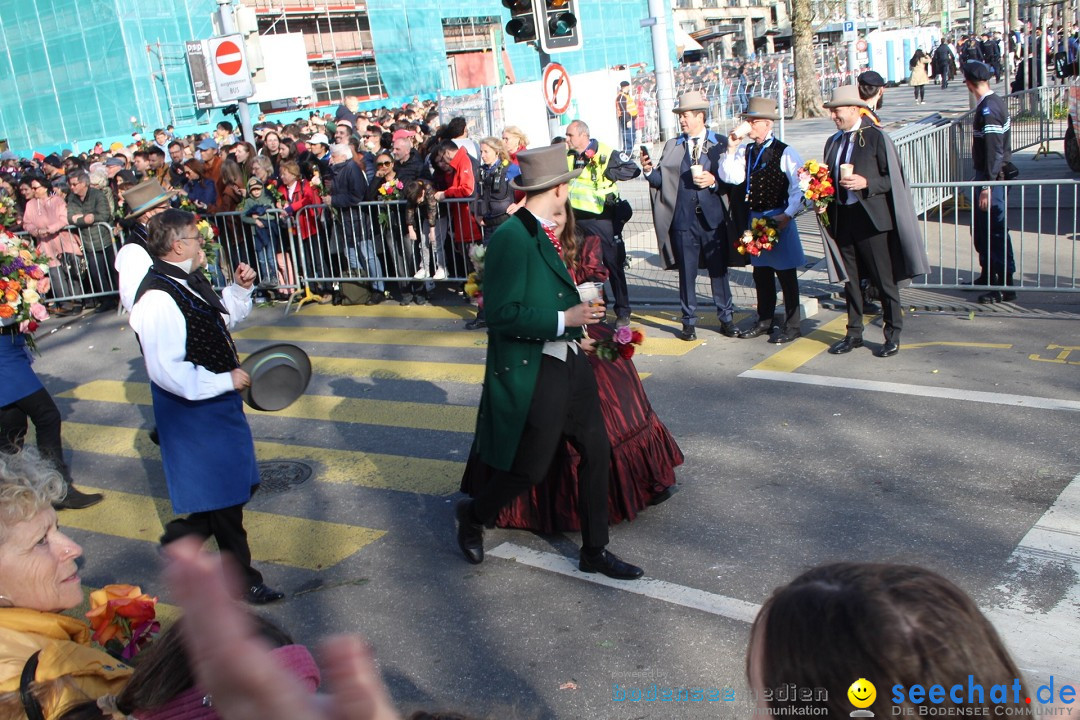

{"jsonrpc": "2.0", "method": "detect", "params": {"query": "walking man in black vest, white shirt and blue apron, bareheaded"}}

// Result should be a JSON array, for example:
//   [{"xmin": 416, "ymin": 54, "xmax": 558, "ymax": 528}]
[{"xmin": 130, "ymin": 209, "xmax": 284, "ymax": 604}]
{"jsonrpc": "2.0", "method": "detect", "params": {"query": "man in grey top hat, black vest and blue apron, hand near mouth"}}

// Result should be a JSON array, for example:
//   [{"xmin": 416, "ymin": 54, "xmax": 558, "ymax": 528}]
[{"xmin": 717, "ymin": 97, "xmax": 806, "ymax": 344}]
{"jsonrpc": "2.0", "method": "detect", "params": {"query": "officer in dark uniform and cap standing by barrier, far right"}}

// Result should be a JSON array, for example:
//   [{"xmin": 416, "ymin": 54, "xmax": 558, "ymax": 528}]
[{"xmin": 960, "ymin": 60, "xmax": 1016, "ymax": 304}]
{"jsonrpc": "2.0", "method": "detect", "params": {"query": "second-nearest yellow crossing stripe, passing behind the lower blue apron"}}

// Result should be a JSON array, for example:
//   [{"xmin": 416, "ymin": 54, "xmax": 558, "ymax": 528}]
[{"xmin": 64, "ymin": 423, "xmax": 464, "ymax": 495}]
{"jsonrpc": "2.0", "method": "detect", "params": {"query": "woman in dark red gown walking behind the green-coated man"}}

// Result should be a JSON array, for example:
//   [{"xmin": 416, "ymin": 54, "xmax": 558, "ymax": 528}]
[{"xmin": 461, "ymin": 199, "xmax": 683, "ymax": 533}]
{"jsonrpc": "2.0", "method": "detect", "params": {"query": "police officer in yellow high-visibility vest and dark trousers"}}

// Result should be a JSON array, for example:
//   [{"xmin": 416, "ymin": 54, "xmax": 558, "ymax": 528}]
[{"xmin": 566, "ymin": 120, "xmax": 642, "ymax": 327}]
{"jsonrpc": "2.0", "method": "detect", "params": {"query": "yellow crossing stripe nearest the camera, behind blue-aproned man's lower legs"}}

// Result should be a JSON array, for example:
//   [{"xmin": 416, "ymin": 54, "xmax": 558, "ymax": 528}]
[{"xmin": 60, "ymin": 487, "xmax": 387, "ymax": 570}]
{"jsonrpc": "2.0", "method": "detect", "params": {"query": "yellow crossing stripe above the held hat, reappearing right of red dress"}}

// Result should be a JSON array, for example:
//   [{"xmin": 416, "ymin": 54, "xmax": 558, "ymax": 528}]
[{"xmin": 232, "ymin": 325, "xmax": 701, "ymax": 355}]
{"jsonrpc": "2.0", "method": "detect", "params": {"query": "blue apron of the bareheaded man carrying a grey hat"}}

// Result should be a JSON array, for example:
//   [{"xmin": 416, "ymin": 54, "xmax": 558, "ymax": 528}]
[{"xmin": 150, "ymin": 382, "xmax": 259, "ymax": 515}]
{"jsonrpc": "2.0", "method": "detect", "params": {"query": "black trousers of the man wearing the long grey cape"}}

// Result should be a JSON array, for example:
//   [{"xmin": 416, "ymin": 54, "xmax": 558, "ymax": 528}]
[{"xmin": 839, "ymin": 232, "xmax": 904, "ymax": 342}]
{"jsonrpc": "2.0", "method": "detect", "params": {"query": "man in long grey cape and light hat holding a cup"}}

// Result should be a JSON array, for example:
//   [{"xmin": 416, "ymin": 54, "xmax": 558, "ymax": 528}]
[{"xmin": 824, "ymin": 85, "xmax": 929, "ymax": 357}]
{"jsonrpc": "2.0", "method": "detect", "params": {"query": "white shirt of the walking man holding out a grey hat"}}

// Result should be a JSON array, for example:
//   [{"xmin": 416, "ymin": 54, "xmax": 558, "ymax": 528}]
[{"xmin": 127, "ymin": 268, "xmax": 254, "ymax": 400}]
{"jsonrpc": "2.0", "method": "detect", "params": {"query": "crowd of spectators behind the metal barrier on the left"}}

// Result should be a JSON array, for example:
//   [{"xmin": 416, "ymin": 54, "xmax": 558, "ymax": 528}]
[{"xmin": 0, "ymin": 97, "xmax": 526, "ymax": 306}]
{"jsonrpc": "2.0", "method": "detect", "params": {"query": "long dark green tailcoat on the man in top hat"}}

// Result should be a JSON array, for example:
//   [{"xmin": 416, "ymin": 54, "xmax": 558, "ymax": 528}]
[{"xmin": 473, "ymin": 208, "xmax": 582, "ymax": 470}]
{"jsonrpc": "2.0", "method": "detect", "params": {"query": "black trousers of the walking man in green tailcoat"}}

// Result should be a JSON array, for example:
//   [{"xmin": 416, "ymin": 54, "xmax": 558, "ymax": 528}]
[{"xmin": 473, "ymin": 350, "xmax": 611, "ymax": 551}]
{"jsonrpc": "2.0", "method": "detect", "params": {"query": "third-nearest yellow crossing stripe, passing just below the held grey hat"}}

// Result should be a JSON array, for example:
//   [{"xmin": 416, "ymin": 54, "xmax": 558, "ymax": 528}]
[{"xmin": 57, "ymin": 380, "xmax": 476, "ymax": 433}]
